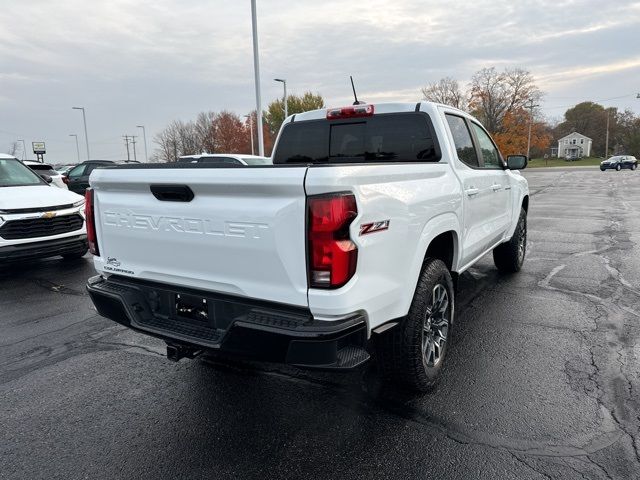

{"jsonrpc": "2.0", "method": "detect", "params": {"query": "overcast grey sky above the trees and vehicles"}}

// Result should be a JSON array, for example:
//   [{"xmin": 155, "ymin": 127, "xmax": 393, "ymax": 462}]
[{"xmin": 0, "ymin": 0, "xmax": 640, "ymax": 163}]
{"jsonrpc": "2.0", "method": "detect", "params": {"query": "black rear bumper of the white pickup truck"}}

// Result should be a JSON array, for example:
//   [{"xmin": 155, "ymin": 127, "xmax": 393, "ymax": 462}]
[{"xmin": 87, "ymin": 276, "xmax": 369, "ymax": 370}]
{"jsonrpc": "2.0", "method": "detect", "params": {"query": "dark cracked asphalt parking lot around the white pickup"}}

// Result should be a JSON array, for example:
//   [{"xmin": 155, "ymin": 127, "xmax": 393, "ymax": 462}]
[{"xmin": 0, "ymin": 168, "xmax": 640, "ymax": 479}]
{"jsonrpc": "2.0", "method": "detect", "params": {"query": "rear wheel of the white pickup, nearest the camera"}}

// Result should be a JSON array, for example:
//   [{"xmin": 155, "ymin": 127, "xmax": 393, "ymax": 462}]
[{"xmin": 377, "ymin": 258, "xmax": 454, "ymax": 392}]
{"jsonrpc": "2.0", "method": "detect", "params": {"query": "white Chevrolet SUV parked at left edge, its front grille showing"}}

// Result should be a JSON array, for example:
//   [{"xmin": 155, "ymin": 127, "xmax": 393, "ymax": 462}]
[{"xmin": 0, "ymin": 154, "xmax": 87, "ymax": 262}]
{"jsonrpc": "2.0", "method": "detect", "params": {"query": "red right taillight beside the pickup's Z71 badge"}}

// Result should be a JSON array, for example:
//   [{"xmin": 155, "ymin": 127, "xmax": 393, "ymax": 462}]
[{"xmin": 307, "ymin": 193, "xmax": 358, "ymax": 288}]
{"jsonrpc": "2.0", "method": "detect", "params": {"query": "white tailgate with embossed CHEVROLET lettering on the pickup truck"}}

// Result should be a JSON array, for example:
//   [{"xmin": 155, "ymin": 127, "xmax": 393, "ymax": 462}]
[{"xmin": 91, "ymin": 167, "xmax": 307, "ymax": 306}]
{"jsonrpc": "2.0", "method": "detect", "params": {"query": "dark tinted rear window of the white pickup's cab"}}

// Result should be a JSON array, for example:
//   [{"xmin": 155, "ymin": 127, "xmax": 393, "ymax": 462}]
[{"xmin": 273, "ymin": 112, "xmax": 441, "ymax": 164}]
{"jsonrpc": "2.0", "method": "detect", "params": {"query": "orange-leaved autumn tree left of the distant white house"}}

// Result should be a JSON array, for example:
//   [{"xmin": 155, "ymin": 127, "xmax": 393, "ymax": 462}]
[{"xmin": 493, "ymin": 108, "xmax": 551, "ymax": 157}]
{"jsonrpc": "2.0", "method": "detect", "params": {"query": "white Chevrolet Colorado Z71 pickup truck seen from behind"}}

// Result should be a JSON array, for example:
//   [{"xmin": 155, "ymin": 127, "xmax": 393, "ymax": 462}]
[{"xmin": 86, "ymin": 102, "xmax": 529, "ymax": 391}]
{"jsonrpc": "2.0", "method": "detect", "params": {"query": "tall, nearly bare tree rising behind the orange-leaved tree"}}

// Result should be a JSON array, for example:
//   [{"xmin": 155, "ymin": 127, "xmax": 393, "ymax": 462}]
[{"xmin": 469, "ymin": 67, "xmax": 542, "ymax": 133}]
